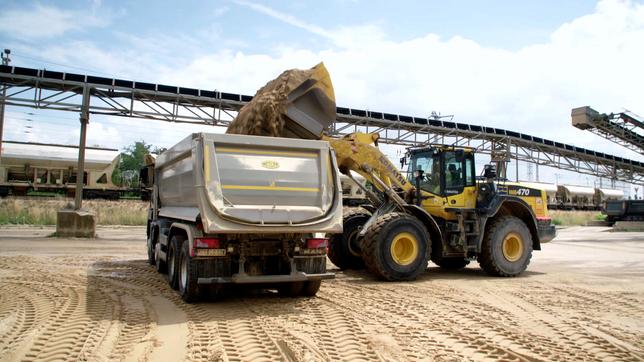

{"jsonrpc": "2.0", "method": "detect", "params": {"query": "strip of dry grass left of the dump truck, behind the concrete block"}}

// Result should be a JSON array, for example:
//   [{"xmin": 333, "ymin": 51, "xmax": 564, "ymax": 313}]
[{"xmin": 0, "ymin": 197, "xmax": 148, "ymax": 225}]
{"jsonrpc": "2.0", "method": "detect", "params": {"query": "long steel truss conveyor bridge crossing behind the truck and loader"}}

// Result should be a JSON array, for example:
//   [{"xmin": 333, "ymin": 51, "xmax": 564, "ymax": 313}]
[{"xmin": 0, "ymin": 66, "xmax": 644, "ymax": 185}]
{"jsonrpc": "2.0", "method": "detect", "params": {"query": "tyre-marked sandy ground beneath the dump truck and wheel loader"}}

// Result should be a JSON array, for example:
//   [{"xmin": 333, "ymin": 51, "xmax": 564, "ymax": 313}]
[{"xmin": 0, "ymin": 227, "xmax": 644, "ymax": 361}]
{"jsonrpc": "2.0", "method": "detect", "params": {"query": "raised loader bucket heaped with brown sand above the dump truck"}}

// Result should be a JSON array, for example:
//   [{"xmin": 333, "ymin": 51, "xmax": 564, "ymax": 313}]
[{"xmin": 226, "ymin": 63, "xmax": 336, "ymax": 139}]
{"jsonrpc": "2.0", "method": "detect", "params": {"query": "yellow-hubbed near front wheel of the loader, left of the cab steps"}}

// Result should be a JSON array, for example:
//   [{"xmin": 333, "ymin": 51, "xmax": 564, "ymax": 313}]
[{"xmin": 362, "ymin": 212, "xmax": 431, "ymax": 281}]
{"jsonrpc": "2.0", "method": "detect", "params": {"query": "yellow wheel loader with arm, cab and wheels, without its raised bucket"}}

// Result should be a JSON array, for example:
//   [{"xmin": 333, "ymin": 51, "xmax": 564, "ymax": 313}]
[{"xmin": 325, "ymin": 133, "xmax": 555, "ymax": 281}]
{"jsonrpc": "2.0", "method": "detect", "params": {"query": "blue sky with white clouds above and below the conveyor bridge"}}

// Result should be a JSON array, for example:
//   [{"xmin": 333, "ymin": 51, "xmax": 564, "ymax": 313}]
[{"xmin": 0, "ymin": 0, "xmax": 644, "ymax": 191}]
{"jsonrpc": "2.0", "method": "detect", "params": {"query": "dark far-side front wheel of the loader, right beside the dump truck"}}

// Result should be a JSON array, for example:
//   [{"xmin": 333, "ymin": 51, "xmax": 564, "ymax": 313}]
[{"xmin": 328, "ymin": 207, "xmax": 371, "ymax": 269}]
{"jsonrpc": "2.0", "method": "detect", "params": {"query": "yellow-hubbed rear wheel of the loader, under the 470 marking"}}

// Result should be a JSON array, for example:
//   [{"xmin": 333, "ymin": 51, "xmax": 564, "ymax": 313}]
[{"xmin": 478, "ymin": 216, "xmax": 532, "ymax": 277}]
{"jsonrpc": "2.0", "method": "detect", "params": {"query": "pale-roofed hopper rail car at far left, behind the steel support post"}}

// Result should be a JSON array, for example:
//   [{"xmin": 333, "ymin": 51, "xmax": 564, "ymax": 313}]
[{"xmin": 0, "ymin": 141, "xmax": 121, "ymax": 199}]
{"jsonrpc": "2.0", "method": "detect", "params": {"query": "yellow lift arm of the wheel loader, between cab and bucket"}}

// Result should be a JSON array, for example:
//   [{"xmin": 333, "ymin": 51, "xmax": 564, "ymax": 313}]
[{"xmin": 322, "ymin": 132, "xmax": 415, "ymax": 201}]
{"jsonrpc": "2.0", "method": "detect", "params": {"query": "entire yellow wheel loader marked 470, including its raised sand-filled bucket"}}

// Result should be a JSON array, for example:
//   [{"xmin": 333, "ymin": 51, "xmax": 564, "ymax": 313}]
[{"xmin": 227, "ymin": 63, "xmax": 555, "ymax": 281}]
